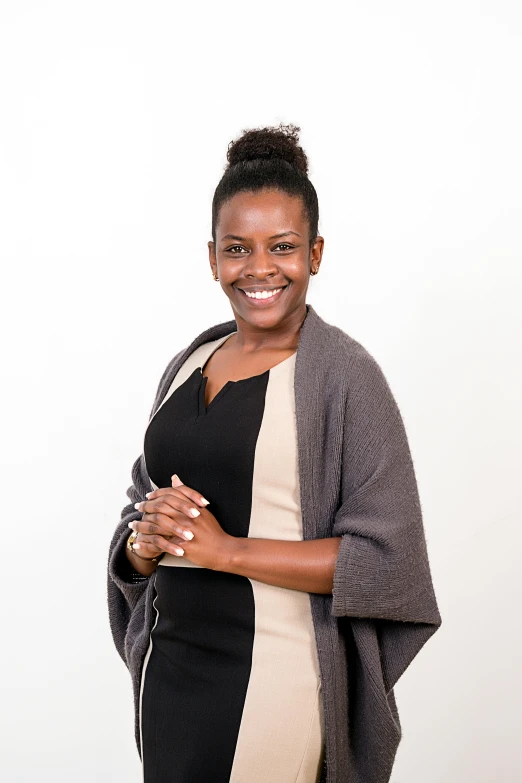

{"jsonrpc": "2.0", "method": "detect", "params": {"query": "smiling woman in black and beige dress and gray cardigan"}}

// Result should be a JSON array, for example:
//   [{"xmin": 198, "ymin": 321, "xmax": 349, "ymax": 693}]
[{"xmin": 108, "ymin": 126, "xmax": 441, "ymax": 783}]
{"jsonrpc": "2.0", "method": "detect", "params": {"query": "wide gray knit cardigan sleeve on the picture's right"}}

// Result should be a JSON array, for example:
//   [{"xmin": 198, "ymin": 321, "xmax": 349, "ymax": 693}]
[{"xmin": 332, "ymin": 346, "xmax": 441, "ymax": 691}]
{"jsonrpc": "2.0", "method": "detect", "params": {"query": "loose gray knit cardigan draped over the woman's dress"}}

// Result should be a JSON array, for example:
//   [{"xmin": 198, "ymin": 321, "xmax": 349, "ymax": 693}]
[{"xmin": 107, "ymin": 304, "xmax": 441, "ymax": 783}]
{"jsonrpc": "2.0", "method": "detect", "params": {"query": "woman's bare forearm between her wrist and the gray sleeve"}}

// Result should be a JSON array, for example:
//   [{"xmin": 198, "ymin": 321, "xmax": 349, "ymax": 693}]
[{"xmin": 215, "ymin": 537, "xmax": 341, "ymax": 593}]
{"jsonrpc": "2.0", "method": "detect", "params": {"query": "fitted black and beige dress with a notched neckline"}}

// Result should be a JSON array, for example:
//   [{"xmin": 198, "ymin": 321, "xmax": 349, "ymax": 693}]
[{"xmin": 139, "ymin": 332, "xmax": 325, "ymax": 783}]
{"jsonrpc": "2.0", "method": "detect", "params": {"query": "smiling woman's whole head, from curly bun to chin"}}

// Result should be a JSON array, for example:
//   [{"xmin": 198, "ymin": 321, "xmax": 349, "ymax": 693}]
[{"xmin": 208, "ymin": 126, "xmax": 324, "ymax": 340}]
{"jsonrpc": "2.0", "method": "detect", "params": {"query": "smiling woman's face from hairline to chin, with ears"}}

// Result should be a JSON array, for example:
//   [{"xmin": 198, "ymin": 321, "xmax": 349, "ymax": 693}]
[{"xmin": 208, "ymin": 189, "xmax": 324, "ymax": 329}]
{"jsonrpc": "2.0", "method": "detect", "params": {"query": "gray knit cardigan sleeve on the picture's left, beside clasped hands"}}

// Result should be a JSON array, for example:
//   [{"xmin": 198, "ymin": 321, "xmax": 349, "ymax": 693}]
[{"xmin": 107, "ymin": 348, "xmax": 186, "ymax": 663}]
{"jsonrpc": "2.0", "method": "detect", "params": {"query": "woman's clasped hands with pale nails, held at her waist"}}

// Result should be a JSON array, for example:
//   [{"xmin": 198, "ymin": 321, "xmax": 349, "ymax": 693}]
[{"xmin": 128, "ymin": 474, "xmax": 235, "ymax": 571}]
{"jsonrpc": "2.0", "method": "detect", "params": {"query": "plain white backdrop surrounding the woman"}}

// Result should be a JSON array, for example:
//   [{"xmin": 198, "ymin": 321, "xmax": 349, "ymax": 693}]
[{"xmin": 0, "ymin": 0, "xmax": 522, "ymax": 783}]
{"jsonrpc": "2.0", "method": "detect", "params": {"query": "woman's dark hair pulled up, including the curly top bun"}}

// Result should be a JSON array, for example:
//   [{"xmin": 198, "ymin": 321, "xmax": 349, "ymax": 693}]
[{"xmin": 212, "ymin": 123, "xmax": 319, "ymax": 247}]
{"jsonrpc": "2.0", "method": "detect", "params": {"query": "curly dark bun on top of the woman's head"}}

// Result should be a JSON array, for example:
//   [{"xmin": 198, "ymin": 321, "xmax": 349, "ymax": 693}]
[{"xmin": 227, "ymin": 123, "xmax": 308, "ymax": 174}]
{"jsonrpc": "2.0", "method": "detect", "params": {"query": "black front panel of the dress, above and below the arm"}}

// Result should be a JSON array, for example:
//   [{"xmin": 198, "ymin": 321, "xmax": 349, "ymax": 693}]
[{"xmin": 141, "ymin": 368, "xmax": 275, "ymax": 783}]
